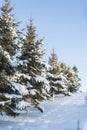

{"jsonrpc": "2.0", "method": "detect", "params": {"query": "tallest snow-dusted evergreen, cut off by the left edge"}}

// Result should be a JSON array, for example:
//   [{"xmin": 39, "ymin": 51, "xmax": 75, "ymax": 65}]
[{"xmin": 0, "ymin": 0, "xmax": 20, "ymax": 115}]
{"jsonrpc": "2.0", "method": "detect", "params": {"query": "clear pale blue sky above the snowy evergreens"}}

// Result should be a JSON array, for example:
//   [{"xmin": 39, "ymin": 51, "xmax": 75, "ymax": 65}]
[{"xmin": 0, "ymin": 0, "xmax": 87, "ymax": 90}]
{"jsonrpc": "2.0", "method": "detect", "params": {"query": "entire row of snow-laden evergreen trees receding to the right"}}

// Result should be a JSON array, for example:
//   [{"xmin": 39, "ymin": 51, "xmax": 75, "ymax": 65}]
[{"xmin": 0, "ymin": 0, "xmax": 80, "ymax": 116}]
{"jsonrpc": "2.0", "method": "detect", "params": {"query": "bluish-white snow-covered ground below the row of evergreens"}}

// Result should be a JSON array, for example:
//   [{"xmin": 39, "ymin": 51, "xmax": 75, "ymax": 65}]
[{"xmin": 0, "ymin": 92, "xmax": 87, "ymax": 130}]
